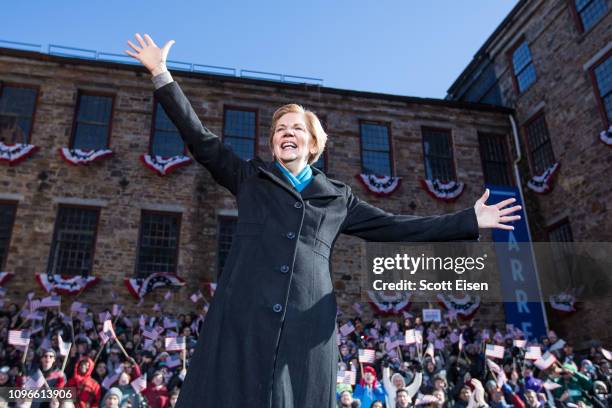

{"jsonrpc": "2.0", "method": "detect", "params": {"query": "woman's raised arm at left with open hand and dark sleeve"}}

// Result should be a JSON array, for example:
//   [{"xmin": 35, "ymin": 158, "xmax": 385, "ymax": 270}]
[{"xmin": 125, "ymin": 34, "xmax": 256, "ymax": 195}]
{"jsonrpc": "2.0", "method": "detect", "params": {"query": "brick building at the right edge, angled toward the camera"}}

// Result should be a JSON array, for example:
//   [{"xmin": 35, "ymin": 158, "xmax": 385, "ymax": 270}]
[{"xmin": 446, "ymin": 0, "xmax": 612, "ymax": 341}]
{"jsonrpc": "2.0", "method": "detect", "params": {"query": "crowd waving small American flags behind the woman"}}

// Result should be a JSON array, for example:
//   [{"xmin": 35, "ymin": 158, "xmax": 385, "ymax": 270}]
[{"xmin": 0, "ymin": 296, "xmax": 612, "ymax": 408}]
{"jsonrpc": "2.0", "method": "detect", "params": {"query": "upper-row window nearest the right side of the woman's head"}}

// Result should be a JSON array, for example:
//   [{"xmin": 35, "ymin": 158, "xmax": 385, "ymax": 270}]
[{"xmin": 359, "ymin": 123, "xmax": 392, "ymax": 176}]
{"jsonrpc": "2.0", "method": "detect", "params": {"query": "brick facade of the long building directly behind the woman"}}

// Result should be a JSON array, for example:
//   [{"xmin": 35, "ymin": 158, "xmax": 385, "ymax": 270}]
[{"xmin": 0, "ymin": 45, "xmax": 511, "ymax": 323}]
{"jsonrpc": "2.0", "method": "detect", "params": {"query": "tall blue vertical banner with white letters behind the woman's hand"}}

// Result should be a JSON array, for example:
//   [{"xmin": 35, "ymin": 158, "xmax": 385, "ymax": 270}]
[{"xmin": 485, "ymin": 185, "xmax": 547, "ymax": 338}]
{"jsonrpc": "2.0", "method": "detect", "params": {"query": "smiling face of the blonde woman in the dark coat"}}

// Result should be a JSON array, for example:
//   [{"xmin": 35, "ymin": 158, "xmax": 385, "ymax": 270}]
[{"xmin": 272, "ymin": 112, "xmax": 316, "ymax": 164}]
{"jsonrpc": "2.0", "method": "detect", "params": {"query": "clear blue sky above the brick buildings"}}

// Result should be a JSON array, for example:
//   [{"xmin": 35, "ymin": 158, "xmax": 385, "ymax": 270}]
[{"xmin": 0, "ymin": 0, "xmax": 517, "ymax": 98}]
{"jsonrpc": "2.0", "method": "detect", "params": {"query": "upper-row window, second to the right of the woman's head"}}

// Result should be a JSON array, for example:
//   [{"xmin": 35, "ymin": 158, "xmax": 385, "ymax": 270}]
[{"xmin": 423, "ymin": 129, "xmax": 455, "ymax": 181}]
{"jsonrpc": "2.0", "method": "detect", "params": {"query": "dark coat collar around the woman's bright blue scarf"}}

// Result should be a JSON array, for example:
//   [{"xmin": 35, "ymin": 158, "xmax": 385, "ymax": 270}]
[{"xmin": 257, "ymin": 162, "xmax": 343, "ymax": 200}]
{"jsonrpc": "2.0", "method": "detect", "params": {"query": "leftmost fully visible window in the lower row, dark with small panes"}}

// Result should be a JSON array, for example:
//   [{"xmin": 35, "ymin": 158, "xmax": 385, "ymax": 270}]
[{"xmin": 48, "ymin": 207, "xmax": 98, "ymax": 276}]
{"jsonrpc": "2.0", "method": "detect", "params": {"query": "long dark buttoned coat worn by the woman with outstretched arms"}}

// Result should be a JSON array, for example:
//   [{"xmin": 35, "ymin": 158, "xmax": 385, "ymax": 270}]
[{"xmin": 155, "ymin": 82, "xmax": 478, "ymax": 408}]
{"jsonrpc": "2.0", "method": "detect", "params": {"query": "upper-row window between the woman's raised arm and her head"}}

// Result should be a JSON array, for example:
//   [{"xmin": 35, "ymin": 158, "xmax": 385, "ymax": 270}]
[{"xmin": 223, "ymin": 109, "xmax": 256, "ymax": 160}]
